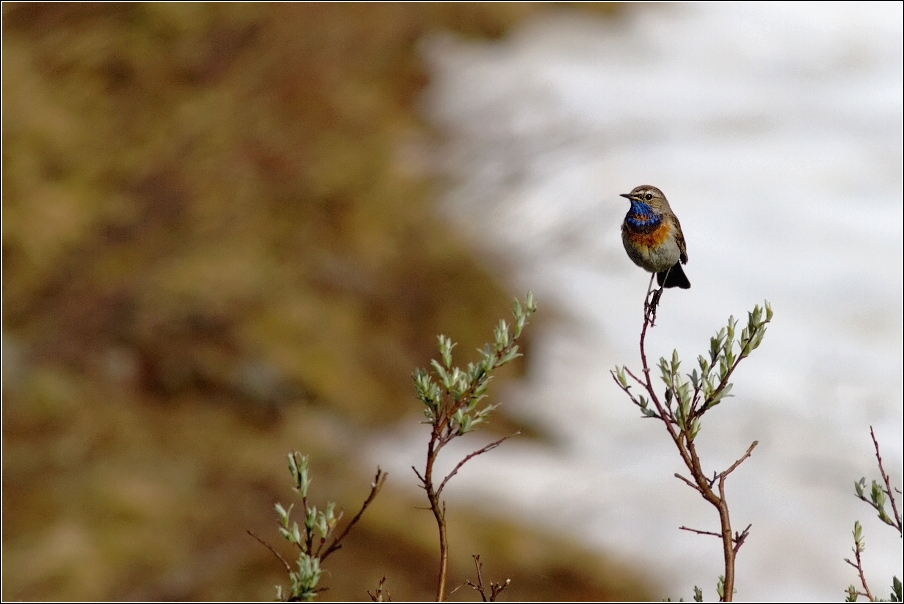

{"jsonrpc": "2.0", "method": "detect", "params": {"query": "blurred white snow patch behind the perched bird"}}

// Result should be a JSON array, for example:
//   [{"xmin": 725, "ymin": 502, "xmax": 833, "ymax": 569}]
[{"xmin": 367, "ymin": 2, "xmax": 904, "ymax": 601}]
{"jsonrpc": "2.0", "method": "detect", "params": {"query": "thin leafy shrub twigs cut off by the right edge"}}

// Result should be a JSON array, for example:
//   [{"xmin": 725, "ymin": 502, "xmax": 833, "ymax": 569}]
[{"xmin": 844, "ymin": 426, "xmax": 902, "ymax": 602}]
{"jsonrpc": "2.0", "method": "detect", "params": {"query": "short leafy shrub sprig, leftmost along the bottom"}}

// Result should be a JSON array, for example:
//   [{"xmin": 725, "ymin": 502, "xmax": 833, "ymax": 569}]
[{"xmin": 248, "ymin": 451, "xmax": 387, "ymax": 602}]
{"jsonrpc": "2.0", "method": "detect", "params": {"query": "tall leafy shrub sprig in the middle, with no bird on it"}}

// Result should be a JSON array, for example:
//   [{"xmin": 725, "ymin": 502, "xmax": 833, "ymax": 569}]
[{"xmin": 412, "ymin": 292, "xmax": 537, "ymax": 602}]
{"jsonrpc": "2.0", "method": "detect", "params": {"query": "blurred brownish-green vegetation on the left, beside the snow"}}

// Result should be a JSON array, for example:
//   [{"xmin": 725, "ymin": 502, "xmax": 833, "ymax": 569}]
[{"xmin": 2, "ymin": 3, "xmax": 643, "ymax": 600}]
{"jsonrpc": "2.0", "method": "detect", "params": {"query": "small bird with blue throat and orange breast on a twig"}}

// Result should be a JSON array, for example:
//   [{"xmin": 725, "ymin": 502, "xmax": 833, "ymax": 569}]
[{"xmin": 621, "ymin": 185, "xmax": 691, "ymax": 289}]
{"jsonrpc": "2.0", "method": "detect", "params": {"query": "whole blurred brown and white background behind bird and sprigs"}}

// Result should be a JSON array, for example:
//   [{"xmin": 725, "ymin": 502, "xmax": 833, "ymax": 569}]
[{"xmin": 2, "ymin": 3, "xmax": 902, "ymax": 600}]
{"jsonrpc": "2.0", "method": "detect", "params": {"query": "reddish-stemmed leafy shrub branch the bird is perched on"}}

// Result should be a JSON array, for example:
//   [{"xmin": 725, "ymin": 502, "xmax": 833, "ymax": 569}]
[{"xmin": 611, "ymin": 296, "xmax": 772, "ymax": 602}]
